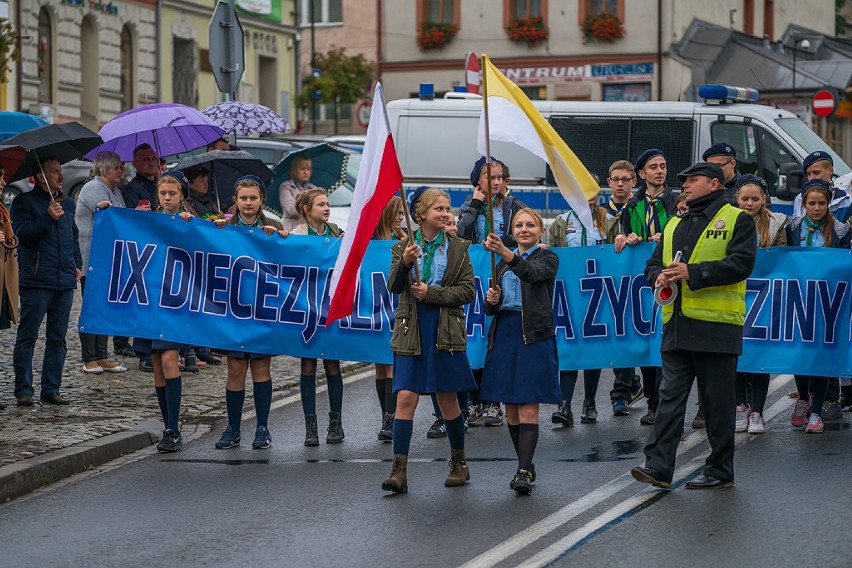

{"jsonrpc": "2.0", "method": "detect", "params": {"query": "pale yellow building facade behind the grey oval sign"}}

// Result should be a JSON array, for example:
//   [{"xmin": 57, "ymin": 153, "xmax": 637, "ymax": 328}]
[{"xmin": 158, "ymin": 0, "xmax": 297, "ymax": 124}]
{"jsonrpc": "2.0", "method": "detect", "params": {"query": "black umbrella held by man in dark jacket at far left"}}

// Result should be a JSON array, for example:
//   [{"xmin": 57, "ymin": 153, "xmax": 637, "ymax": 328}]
[{"xmin": 5, "ymin": 122, "xmax": 103, "ymax": 183}]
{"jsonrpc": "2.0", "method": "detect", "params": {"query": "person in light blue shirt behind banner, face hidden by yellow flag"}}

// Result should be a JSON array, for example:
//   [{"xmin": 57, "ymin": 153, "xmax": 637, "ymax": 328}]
[{"xmin": 548, "ymin": 192, "xmax": 619, "ymax": 426}]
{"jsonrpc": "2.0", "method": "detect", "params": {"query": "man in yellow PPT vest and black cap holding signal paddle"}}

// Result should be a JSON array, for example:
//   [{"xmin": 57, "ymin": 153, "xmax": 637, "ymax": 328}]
[{"xmin": 631, "ymin": 162, "xmax": 757, "ymax": 489}]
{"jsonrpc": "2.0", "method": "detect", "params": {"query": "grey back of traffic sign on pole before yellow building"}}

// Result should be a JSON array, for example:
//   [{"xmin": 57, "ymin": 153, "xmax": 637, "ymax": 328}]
[{"xmin": 210, "ymin": 0, "xmax": 246, "ymax": 98}]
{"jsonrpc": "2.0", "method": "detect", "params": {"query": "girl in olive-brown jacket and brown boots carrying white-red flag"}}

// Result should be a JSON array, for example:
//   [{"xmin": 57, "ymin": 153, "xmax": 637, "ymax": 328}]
[{"xmin": 382, "ymin": 187, "xmax": 476, "ymax": 493}]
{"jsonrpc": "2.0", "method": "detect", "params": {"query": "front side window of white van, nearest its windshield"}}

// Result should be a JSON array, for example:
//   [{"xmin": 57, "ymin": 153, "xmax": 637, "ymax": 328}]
[{"xmin": 710, "ymin": 122, "xmax": 798, "ymax": 195}]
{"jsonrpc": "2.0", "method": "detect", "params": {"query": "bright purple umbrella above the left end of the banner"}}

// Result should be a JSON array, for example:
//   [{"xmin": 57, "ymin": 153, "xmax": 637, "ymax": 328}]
[{"xmin": 86, "ymin": 103, "xmax": 224, "ymax": 162}]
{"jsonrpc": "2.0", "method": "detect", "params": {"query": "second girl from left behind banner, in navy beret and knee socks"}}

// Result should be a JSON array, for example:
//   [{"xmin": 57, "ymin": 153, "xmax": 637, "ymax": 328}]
[{"xmin": 215, "ymin": 176, "xmax": 287, "ymax": 450}]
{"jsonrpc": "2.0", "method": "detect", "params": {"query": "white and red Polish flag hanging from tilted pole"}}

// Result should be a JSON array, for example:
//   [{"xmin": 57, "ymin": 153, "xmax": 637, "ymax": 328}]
[{"xmin": 326, "ymin": 83, "xmax": 402, "ymax": 325}]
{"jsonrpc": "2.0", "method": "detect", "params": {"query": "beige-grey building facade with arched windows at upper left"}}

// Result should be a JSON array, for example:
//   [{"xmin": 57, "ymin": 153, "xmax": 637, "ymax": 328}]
[{"xmin": 7, "ymin": 0, "xmax": 157, "ymax": 130}]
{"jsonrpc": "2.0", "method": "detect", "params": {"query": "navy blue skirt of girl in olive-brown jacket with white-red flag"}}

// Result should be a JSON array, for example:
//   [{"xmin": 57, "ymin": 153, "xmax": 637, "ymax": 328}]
[{"xmin": 393, "ymin": 302, "xmax": 476, "ymax": 394}]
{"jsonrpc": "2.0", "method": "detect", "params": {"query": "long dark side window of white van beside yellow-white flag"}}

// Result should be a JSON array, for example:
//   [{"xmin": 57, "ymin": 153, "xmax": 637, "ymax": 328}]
[{"xmin": 547, "ymin": 115, "xmax": 695, "ymax": 187}]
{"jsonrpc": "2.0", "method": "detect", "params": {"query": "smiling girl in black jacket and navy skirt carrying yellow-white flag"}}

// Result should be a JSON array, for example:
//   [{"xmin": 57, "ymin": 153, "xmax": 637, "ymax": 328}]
[{"xmin": 482, "ymin": 209, "xmax": 564, "ymax": 495}]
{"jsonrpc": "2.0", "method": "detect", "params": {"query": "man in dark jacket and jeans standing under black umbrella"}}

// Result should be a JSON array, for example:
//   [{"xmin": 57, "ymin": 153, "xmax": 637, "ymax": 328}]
[{"xmin": 12, "ymin": 157, "xmax": 83, "ymax": 406}]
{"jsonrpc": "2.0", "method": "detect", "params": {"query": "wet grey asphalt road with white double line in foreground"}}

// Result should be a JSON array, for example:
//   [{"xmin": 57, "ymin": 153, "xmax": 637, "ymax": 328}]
[{"xmin": 0, "ymin": 373, "xmax": 852, "ymax": 567}]
